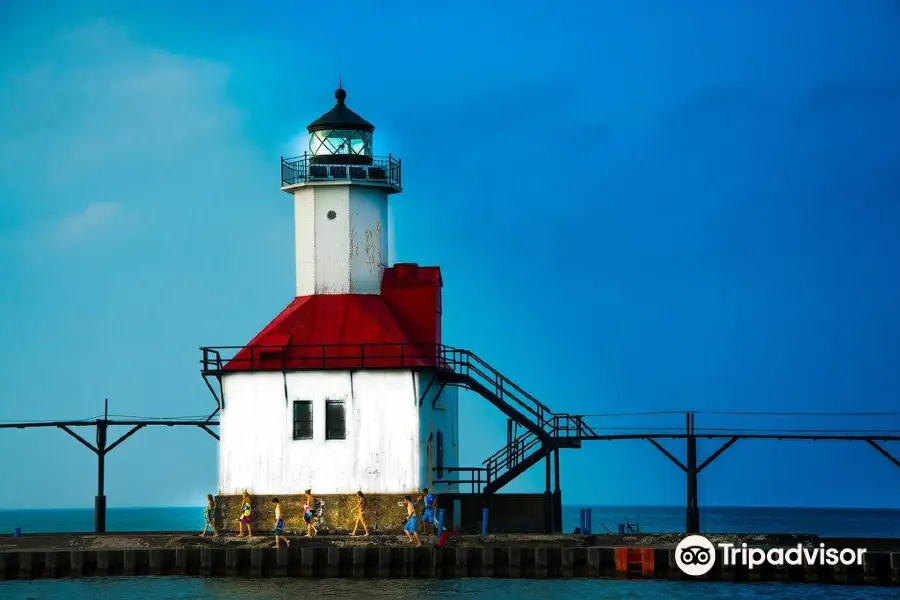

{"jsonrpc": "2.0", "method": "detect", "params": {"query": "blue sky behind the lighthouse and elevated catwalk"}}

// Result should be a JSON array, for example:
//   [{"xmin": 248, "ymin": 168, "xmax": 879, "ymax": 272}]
[{"xmin": 0, "ymin": 0, "xmax": 900, "ymax": 508}]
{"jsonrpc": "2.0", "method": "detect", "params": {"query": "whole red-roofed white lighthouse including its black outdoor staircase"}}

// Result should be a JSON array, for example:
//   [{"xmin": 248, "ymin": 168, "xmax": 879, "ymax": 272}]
[{"xmin": 200, "ymin": 87, "xmax": 584, "ymax": 533}]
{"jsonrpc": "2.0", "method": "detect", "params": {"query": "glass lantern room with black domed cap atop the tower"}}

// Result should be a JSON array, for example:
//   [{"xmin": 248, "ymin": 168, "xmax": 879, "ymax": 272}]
[{"xmin": 306, "ymin": 87, "xmax": 375, "ymax": 165}]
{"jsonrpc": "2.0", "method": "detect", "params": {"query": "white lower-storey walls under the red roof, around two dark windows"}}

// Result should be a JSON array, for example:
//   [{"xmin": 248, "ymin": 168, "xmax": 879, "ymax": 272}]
[{"xmin": 219, "ymin": 371, "xmax": 459, "ymax": 494}]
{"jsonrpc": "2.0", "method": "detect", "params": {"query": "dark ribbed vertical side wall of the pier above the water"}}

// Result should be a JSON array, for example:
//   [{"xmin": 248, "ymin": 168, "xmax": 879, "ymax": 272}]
[{"xmin": 0, "ymin": 546, "xmax": 900, "ymax": 586}]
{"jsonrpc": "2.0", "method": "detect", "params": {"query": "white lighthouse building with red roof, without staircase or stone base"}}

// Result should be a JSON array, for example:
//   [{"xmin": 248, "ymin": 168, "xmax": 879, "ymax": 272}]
[{"xmin": 216, "ymin": 89, "xmax": 459, "ymax": 496}]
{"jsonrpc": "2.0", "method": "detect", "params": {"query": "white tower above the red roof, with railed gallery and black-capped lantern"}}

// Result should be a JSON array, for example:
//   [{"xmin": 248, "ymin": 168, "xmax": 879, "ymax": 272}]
[{"xmin": 281, "ymin": 88, "xmax": 401, "ymax": 296}]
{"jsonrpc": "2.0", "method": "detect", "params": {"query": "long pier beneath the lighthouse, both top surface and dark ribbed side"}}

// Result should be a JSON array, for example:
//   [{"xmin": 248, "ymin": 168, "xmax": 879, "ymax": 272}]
[{"xmin": 0, "ymin": 534, "xmax": 900, "ymax": 589}]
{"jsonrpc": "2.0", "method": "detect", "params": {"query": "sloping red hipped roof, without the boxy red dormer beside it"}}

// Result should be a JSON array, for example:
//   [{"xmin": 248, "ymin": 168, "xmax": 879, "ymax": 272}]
[{"xmin": 224, "ymin": 294, "xmax": 435, "ymax": 371}]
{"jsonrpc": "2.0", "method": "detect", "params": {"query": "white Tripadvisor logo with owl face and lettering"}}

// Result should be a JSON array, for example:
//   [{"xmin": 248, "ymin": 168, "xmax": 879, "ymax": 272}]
[{"xmin": 675, "ymin": 535, "xmax": 866, "ymax": 577}]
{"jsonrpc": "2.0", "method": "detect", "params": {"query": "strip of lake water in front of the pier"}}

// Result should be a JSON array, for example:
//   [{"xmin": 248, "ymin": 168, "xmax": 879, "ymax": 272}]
[{"xmin": 0, "ymin": 577, "xmax": 898, "ymax": 600}]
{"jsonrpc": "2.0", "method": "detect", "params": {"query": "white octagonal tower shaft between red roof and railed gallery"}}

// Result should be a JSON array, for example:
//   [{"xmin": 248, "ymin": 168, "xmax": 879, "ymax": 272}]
[{"xmin": 294, "ymin": 182, "xmax": 388, "ymax": 296}]
